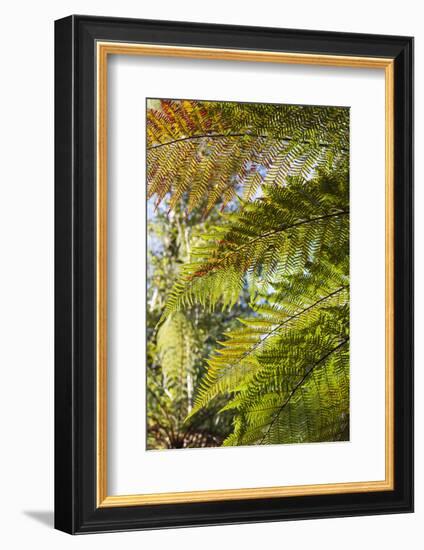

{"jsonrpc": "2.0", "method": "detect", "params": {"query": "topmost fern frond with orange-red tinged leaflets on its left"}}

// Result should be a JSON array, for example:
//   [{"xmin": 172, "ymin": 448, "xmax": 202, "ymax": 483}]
[{"xmin": 147, "ymin": 100, "xmax": 349, "ymax": 213}]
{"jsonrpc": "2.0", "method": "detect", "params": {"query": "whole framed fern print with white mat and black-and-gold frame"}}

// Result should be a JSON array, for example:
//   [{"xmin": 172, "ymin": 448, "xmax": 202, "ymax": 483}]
[{"xmin": 55, "ymin": 16, "xmax": 413, "ymax": 533}]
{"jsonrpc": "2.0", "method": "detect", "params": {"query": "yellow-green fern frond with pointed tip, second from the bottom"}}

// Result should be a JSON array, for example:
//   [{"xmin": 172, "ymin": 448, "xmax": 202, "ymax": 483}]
[{"xmin": 188, "ymin": 287, "xmax": 349, "ymax": 414}]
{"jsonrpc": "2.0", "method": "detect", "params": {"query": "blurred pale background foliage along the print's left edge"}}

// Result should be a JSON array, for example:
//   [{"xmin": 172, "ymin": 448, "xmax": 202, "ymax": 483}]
[{"xmin": 147, "ymin": 196, "xmax": 238, "ymax": 449}]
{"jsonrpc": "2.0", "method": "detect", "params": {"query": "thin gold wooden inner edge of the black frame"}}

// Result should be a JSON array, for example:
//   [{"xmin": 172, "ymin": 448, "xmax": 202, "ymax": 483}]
[{"xmin": 96, "ymin": 41, "xmax": 395, "ymax": 508}]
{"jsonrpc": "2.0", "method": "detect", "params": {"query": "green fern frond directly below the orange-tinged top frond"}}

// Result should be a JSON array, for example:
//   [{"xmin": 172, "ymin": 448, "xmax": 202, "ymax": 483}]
[{"xmin": 164, "ymin": 174, "xmax": 349, "ymax": 316}]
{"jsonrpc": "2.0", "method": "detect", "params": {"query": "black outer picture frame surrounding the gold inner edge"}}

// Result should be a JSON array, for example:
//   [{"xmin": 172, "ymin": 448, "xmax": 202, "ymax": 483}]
[{"xmin": 55, "ymin": 15, "xmax": 413, "ymax": 534}]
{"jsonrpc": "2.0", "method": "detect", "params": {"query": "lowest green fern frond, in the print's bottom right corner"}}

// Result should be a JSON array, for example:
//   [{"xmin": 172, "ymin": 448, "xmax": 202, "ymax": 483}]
[{"xmin": 224, "ymin": 340, "xmax": 349, "ymax": 445}]
